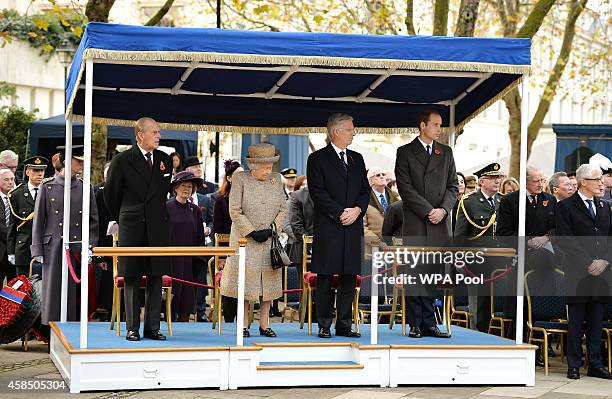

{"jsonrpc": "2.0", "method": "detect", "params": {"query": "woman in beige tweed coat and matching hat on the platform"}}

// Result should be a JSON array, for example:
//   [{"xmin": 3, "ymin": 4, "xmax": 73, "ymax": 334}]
[{"xmin": 221, "ymin": 143, "xmax": 287, "ymax": 337}]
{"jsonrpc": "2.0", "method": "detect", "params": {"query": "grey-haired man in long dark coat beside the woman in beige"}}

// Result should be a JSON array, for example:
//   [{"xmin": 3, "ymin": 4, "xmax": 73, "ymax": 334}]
[{"xmin": 307, "ymin": 114, "xmax": 370, "ymax": 338}]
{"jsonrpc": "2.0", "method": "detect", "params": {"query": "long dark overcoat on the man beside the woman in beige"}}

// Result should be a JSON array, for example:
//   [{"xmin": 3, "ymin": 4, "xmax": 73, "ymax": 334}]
[{"xmin": 306, "ymin": 144, "xmax": 370, "ymax": 275}]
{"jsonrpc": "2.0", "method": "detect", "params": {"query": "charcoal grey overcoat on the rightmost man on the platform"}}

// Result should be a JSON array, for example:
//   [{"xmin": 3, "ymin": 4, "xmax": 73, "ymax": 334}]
[{"xmin": 394, "ymin": 138, "xmax": 459, "ymax": 246}]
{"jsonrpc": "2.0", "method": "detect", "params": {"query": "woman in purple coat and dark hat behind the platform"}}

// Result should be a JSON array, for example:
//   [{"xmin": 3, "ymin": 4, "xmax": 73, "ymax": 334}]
[{"xmin": 166, "ymin": 172, "xmax": 204, "ymax": 321}]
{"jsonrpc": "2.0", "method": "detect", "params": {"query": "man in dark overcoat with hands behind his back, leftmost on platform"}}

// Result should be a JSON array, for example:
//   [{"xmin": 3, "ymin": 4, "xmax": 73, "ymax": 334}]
[{"xmin": 104, "ymin": 117, "xmax": 172, "ymax": 341}]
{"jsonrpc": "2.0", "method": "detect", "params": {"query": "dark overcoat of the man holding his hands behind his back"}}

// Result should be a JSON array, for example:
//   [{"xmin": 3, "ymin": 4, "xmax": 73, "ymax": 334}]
[{"xmin": 104, "ymin": 145, "xmax": 172, "ymax": 277}]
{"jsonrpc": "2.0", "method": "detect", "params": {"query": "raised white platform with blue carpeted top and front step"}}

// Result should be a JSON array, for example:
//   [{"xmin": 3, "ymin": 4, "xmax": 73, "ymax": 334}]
[{"xmin": 50, "ymin": 323, "xmax": 535, "ymax": 392}]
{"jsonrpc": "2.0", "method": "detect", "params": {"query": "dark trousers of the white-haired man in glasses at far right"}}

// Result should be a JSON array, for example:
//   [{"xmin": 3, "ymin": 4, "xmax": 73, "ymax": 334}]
[{"xmin": 567, "ymin": 302, "xmax": 604, "ymax": 368}]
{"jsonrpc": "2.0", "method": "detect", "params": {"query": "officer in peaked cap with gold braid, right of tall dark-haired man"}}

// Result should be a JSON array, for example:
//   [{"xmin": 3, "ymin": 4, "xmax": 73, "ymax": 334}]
[{"xmin": 454, "ymin": 162, "xmax": 502, "ymax": 332}]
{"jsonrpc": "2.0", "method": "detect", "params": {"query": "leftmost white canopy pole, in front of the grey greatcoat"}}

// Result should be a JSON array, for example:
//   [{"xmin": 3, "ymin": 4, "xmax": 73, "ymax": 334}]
[{"xmin": 60, "ymin": 118, "xmax": 72, "ymax": 323}]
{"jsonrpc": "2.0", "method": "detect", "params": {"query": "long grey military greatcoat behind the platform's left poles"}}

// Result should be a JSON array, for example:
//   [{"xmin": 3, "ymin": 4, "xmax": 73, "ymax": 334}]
[{"xmin": 30, "ymin": 176, "xmax": 98, "ymax": 324}]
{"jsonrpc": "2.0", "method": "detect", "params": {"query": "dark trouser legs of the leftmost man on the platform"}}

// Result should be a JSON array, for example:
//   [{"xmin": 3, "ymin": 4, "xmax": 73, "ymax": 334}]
[{"xmin": 124, "ymin": 276, "xmax": 161, "ymax": 331}]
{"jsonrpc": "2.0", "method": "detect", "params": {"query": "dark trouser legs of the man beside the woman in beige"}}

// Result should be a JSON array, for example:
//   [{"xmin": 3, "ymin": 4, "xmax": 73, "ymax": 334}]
[{"xmin": 315, "ymin": 274, "xmax": 357, "ymax": 331}]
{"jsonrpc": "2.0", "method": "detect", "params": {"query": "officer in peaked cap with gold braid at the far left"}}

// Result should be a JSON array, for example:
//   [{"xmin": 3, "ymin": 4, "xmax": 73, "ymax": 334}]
[{"xmin": 8, "ymin": 156, "xmax": 49, "ymax": 276}]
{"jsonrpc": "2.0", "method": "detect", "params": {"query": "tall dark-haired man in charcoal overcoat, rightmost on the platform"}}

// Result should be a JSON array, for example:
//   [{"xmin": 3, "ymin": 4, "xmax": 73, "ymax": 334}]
[{"xmin": 395, "ymin": 110, "xmax": 458, "ymax": 338}]
